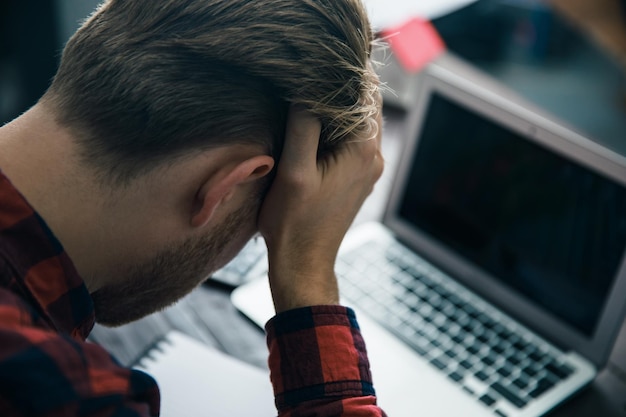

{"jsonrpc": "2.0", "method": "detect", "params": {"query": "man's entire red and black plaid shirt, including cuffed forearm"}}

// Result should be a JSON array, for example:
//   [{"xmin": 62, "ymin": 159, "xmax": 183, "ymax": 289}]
[{"xmin": 0, "ymin": 173, "xmax": 384, "ymax": 417}]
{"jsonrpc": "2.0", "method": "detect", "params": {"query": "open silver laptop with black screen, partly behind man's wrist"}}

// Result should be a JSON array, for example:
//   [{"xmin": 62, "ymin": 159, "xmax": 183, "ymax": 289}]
[{"xmin": 227, "ymin": 55, "xmax": 626, "ymax": 417}]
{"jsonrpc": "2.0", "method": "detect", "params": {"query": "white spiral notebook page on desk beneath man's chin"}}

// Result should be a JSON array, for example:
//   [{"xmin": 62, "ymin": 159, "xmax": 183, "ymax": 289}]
[{"xmin": 135, "ymin": 330, "xmax": 277, "ymax": 417}]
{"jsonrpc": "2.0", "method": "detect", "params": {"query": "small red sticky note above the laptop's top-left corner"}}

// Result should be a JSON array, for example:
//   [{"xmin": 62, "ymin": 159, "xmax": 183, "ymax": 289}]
[{"xmin": 382, "ymin": 18, "xmax": 446, "ymax": 72}]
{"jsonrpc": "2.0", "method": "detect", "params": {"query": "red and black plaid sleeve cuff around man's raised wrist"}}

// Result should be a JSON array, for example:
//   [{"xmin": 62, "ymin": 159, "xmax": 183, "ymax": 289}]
[{"xmin": 266, "ymin": 306, "xmax": 386, "ymax": 417}]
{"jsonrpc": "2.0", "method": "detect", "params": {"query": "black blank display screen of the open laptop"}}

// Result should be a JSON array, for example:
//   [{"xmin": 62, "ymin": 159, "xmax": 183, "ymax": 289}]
[{"xmin": 400, "ymin": 94, "xmax": 626, "ymax": 336}]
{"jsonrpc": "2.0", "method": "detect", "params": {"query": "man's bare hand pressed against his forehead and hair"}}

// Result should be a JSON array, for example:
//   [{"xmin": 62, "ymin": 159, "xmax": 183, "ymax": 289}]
[{"xmin": 259, "ymin": 102, "xmax": 384, "ymax": 313}]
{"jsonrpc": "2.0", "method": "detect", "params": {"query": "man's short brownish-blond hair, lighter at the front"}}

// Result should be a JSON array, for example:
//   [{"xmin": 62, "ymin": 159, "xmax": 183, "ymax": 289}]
[{"xmin": 44, "ymin": 0, "xmax": 378, "ymax": 182}]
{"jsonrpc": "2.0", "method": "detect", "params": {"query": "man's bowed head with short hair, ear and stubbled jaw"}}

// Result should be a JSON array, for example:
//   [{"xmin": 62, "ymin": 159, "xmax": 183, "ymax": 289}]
[{"xmin": 8, "ymin": 0, "xmax": 377, "ymax": 325}]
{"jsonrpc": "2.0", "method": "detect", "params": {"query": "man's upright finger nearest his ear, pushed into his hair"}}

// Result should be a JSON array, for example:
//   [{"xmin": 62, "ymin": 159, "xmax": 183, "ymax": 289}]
[{"xmin": 279, "ymin": 106, "xmax": 322, "ymax": 174}]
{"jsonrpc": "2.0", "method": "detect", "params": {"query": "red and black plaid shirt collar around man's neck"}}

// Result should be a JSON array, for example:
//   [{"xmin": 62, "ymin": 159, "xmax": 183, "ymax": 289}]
[{"xmin": 0, "ymin": 172, "xmax": 95, "ymax": 340}]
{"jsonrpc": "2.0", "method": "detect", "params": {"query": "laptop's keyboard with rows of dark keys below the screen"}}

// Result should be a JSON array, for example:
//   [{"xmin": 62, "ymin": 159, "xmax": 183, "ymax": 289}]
[{"xmin": 337, "ymin": 239, "xmax": 574, "ymax": 416}]
